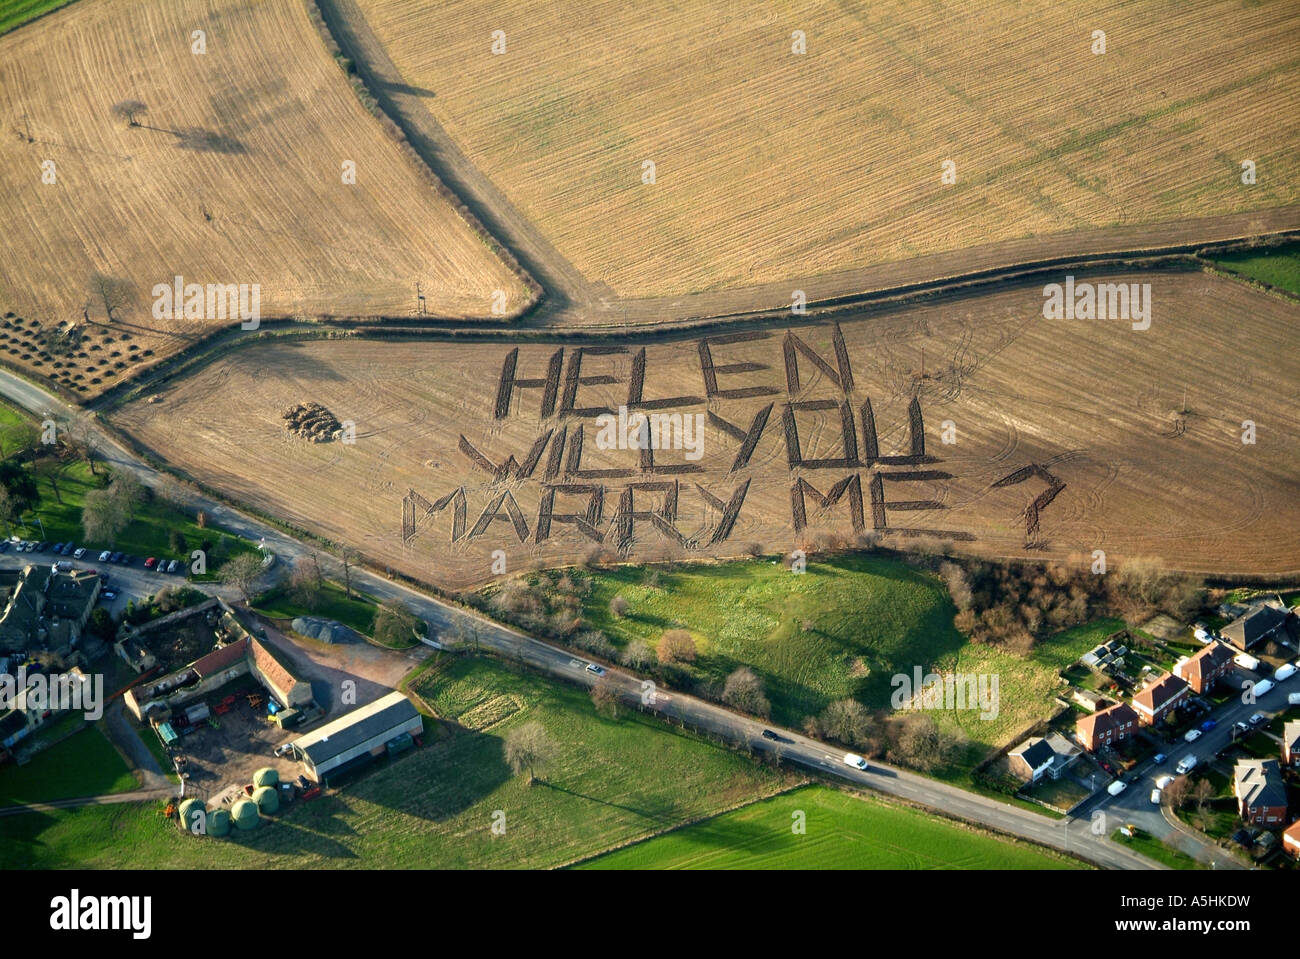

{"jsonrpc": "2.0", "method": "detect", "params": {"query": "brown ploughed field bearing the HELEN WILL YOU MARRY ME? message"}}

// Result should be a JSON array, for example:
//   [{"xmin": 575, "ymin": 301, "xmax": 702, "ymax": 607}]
[{"xmin": 113, "ymin": 273, "xmax": 1300, "ymax": 586}]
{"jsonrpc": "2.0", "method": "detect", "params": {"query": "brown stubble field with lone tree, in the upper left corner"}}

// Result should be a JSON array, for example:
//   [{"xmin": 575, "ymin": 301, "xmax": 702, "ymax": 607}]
[{"xmin": 0, "ymin": 0, "xmax": 529, "ymax": 395}]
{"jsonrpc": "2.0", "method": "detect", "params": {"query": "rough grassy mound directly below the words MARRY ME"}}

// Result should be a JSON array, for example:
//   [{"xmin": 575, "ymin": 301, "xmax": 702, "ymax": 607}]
[{"xmin": 525, "ymin": 556, "xmax": 966, "ymax": 725}]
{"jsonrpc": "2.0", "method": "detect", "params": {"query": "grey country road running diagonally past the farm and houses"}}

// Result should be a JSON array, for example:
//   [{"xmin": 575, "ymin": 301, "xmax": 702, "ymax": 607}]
[{"xmin": 0, "ymin": 361, "xmax": 1180, "ymax": 869}]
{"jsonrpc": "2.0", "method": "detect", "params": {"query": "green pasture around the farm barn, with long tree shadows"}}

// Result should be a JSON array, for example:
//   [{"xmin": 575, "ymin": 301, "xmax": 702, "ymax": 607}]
[{"xmin": 0, "ymin": 659, "xmax": 794, "ymax": 869}]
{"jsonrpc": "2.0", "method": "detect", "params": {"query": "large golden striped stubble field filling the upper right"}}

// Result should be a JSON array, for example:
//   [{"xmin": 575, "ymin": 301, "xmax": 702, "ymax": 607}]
[{"xmin": 348, "ymin": 0, "xmax": 1300, "ymax": 298}]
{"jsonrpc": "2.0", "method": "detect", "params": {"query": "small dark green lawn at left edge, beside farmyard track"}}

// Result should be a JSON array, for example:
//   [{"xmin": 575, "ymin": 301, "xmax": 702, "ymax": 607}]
[{"xmin": 0, "ymin": 725, "xmax": 138, "ymax": 806}]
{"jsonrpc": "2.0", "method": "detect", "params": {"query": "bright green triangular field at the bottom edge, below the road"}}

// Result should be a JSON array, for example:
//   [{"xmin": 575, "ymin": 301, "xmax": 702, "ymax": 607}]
[{"xmin": 579, "ymin": 786, "xmax": 1084, "ymax": 869}]
